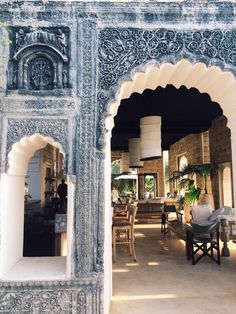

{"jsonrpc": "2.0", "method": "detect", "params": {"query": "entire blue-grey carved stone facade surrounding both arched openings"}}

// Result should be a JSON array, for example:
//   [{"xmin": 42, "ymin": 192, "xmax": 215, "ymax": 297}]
[{"xmin": 0, "ymin": 0, "xmax": 236, "ymax": 314}]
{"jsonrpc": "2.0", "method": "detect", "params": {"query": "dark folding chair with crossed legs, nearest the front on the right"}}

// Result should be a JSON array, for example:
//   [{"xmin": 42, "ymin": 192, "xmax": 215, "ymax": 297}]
[{"xmin": 186, "ymin": 222, "xmax": 220, "ymax": 265}]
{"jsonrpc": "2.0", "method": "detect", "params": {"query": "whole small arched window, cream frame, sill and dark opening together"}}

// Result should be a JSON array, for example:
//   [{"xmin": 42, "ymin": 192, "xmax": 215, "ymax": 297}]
[{"xmin": 0, "ymin": 134, "xmax": 74, "ymax": 281}]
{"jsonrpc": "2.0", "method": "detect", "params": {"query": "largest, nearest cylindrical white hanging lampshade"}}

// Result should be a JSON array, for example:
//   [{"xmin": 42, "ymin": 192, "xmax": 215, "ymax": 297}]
[{"xmin": 140, "ymin": 116, "xmax": 161, "ymax": 160}]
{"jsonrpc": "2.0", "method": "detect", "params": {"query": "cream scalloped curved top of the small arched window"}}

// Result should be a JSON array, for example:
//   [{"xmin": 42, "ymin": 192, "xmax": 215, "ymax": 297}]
[{"xmin": 7, "ymin": 133, "xmax": 65, "ymax": 175}]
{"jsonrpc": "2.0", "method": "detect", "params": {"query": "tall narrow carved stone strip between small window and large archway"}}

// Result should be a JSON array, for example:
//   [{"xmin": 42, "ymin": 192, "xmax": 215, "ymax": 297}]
[{"xmin": 75, "ymin": 19, "xmax": 98, "ymax": 276}]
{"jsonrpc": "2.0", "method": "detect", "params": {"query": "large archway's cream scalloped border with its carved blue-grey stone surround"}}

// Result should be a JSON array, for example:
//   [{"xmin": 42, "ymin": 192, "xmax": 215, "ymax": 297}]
[{"xmin": 97, "ymin": 29, "xmax": 236, "ymax": 312}]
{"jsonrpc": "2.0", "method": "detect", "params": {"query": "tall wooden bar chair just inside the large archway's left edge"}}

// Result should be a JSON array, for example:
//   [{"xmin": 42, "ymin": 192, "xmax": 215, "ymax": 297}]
[{"xmin": 112, "ymin": 204, "xmax": 137, "ymax": 262}]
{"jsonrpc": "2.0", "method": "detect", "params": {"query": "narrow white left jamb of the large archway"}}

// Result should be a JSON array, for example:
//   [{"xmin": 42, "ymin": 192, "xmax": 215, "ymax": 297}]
[{"xmin": 104, "ymin": 124, "xmax": 113, "ymax": 314}]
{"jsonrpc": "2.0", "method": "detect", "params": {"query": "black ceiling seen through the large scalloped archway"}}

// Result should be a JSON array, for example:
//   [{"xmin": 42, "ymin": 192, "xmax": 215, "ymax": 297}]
[{"xmin": 111, "ymin": 85, "xmax": 222, "ymax": 150}]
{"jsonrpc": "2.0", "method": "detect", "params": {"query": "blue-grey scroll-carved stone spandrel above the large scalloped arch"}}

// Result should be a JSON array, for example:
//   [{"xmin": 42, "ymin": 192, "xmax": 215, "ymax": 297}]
[{"xmin": 99, "ymin": 28, "xmax": 236, "ymax": 93}]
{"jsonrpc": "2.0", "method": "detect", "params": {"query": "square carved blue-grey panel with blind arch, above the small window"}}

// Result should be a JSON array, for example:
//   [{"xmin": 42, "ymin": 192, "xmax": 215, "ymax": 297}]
[{"xmin": 8, "ymin": 27, "xmax": 70, "ymax": 93}]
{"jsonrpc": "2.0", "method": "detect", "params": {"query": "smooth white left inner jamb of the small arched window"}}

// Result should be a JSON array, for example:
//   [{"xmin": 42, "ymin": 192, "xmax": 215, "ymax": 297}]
[{"xmin": 0, "ymin": 174, "xmax": 25, "ymax": 278}]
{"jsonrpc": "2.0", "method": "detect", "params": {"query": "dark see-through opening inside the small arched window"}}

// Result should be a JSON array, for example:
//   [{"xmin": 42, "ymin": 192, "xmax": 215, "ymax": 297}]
[{"xmin": 23, "ymin": 144, "xmax": 67, "ymax": 256}]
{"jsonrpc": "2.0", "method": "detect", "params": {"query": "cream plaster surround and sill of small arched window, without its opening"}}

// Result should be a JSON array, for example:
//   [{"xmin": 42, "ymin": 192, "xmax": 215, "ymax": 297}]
[{"xmin": 0, "ymin": 134, "xmax": 74, "ymax": 281}]
